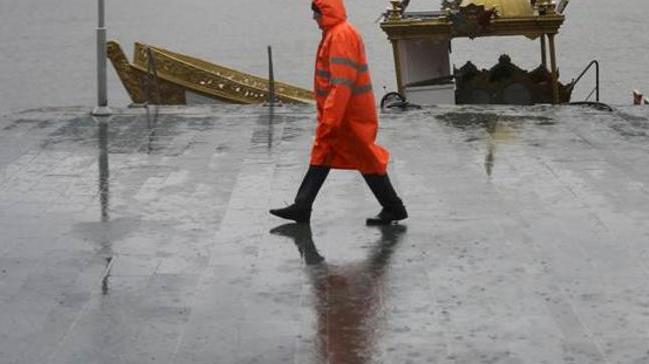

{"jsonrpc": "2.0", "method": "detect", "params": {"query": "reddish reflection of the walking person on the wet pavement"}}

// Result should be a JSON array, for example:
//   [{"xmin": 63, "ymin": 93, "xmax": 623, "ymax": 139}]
[{"xmin": 271, "ymin": 224, "xmax": 406, "ymax": 364}]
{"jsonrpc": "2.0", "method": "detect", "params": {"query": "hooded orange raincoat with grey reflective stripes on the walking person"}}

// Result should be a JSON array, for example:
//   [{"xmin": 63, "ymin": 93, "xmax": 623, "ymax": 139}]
[{"xmin": 310, "ymin": 0, "xmax": 390, "ymax": 175}]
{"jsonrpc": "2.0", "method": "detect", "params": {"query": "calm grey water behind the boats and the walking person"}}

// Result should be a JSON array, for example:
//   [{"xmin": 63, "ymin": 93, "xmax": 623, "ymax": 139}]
[{"xmin": 0, "ymin": 0, "xmax": 649, "ymax": 114}]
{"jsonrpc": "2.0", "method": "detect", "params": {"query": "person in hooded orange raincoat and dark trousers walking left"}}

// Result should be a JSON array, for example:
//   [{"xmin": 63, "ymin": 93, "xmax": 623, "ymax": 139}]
[{"xmin": 270, "ymin": 0, "xmax": 408, "ymax": 225}]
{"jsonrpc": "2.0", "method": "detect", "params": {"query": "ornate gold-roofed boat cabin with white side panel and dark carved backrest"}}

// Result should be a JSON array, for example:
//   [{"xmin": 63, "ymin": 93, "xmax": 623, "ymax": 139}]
[{"xmin": 381, "ymin": 0, "xmax": 574, "ymax": 105}]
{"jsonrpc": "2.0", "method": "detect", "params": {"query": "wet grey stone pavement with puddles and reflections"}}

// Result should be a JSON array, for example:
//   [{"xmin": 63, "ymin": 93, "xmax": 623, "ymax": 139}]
[{"xmin": 0, "ymin": 106, "xmax": 649, "ymax": 364}]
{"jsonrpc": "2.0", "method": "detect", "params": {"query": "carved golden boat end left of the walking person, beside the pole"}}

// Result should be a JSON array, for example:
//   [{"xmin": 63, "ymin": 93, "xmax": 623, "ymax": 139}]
[{"xmin": 106, "ymin": 41, "xmax": 314, "ymax": 105}]
